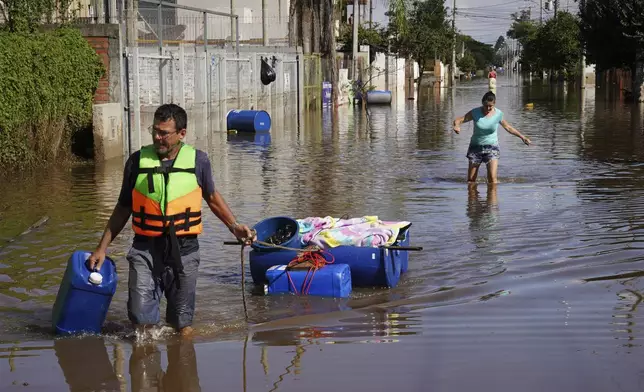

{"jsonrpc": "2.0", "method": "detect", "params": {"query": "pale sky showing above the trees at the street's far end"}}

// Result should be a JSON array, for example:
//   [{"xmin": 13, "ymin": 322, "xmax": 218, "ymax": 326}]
[{"xmin": 358, "ymin": 0, "xmax": 578, "ymax": 45}]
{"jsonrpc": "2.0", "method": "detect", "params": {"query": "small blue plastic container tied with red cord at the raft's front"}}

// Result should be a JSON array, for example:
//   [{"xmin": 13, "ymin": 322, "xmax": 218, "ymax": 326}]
[{"xmin": 266, "ymin": 264, "xmax": 352, "ymax": 298}]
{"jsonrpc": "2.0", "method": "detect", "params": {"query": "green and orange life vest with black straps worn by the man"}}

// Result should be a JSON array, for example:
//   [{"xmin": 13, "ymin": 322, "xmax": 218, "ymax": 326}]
[{"xmin": 132, "ymin": 144, "xmax": 202, "ymax": 237}]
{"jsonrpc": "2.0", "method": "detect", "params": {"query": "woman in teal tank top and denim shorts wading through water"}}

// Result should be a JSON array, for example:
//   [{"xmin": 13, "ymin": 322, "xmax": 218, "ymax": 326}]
[{"xmin": 454, "ymin": 91, "xmax": 530, "ymax": 184}]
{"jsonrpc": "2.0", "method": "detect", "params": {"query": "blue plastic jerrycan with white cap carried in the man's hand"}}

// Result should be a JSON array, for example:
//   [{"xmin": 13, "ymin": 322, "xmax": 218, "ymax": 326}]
[{"xmin": 52, "ymin": 251, "xmax": 118, "ymax": 335}]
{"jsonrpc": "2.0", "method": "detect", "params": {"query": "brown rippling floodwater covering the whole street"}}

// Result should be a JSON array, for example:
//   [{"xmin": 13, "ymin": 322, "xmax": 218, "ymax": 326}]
[{"xmin": 0, "ymin": 77, "xmax": 644, "ymax": 391}]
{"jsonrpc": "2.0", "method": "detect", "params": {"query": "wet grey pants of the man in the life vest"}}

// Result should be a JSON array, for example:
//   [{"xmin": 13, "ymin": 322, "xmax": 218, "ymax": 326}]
[{"xmin": 127, "ymin": 236, "xmax": 200, "ymax": 329}]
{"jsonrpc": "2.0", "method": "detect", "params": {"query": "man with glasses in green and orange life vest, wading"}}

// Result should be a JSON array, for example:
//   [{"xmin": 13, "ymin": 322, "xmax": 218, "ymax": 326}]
[{"xmin": 87, "ymin": 104, "xmax": 255, "ymax": 335}]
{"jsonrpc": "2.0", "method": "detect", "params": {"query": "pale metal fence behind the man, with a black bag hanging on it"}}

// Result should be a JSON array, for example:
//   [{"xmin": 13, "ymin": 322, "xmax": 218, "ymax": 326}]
[{"xmin": 127, "ymin": 45, "xmax": 304, "ymax": 150}]
